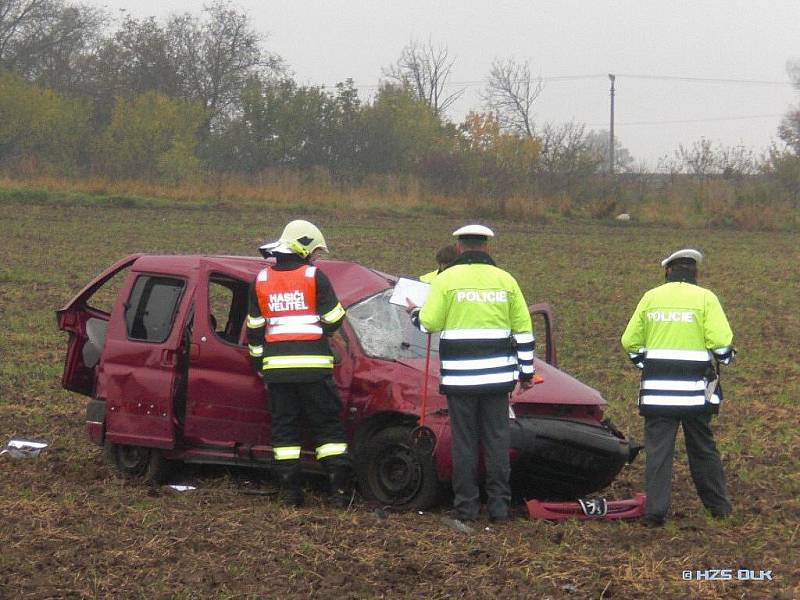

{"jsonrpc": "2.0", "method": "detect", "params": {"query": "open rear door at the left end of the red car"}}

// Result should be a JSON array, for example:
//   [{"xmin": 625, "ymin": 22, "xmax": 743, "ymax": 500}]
[{"xmin": 56, "ymin": 254, "xmax": 141, "ymax": 396}]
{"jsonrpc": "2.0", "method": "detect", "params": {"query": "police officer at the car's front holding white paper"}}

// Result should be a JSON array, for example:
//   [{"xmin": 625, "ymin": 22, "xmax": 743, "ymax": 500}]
[{"xmin": 409, "ymin": 225, "xmax": 534, "ymax": 521}]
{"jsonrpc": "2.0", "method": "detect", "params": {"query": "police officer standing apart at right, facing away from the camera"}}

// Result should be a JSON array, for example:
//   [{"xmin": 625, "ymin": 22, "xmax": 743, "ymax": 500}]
[{"xmin": 622, "ymin": 248, "xmax": 735, "ymax": 527}]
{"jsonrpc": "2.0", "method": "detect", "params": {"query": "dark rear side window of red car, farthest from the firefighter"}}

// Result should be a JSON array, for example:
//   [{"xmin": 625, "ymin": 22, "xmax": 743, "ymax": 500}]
[{"xmin": 125, "ymin": 275, "xmax": 184, "ymax": 342}]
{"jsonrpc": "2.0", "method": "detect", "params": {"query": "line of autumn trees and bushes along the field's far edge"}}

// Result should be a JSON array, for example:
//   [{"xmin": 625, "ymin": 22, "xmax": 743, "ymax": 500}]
[{"xmin": 0, "ymin": 0, "xmax": 800, "ymax": 211}]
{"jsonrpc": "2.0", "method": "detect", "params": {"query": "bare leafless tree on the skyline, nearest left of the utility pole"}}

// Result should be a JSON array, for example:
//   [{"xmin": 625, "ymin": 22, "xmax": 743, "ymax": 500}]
[{"xmin": 483, "ymin": 58, "xmax": 544, "ymax": 138}]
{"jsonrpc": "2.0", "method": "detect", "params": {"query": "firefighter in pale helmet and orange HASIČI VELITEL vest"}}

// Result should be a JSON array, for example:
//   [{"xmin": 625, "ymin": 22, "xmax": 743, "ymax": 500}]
[{"xmin": 247, "ymin": 220, "xmax": 352, "ymax": 507}]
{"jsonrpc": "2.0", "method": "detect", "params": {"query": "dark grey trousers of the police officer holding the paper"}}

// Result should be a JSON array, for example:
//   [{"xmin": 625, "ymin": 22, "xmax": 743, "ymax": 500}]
[{"xmin": 447, "ymin": 394, "xmax": 511, "ymax": 519}]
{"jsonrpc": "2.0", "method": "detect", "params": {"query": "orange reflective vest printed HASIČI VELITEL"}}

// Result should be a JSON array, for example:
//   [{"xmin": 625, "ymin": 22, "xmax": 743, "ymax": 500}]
[{"xmin": 255, "ymin": 266, "xmax": 322, "ymax": 342}]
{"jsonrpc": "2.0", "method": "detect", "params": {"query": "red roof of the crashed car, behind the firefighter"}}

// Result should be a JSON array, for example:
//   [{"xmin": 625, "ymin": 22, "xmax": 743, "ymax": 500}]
[{"xmin": 132, "ymin": 254, "xmax": 396, "ymax": 306}]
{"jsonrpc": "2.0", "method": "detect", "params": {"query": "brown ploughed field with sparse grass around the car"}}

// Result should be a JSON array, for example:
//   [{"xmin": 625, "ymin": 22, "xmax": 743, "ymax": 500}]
[{"xmin": 0, "ymin": 199, "xmax": 800, "ymax": 600}]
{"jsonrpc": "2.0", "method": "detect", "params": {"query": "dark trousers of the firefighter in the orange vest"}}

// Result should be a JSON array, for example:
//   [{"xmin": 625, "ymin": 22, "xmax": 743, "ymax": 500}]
[{"xmin": 266, "ymin": 377, "xmax": 350, "ymax": 471}]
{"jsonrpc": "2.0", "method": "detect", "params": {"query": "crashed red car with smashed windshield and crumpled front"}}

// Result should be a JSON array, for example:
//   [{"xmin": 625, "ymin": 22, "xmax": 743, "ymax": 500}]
[{"xmin": 57, "ymin": 255, "xmax": 636, "ymax": 509}]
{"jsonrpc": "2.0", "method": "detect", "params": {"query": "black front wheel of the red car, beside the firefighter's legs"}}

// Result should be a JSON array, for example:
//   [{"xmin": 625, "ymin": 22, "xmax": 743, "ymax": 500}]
[{"xmin": 357, "ymin": 426, "xmax": 442, "ymax": 510}]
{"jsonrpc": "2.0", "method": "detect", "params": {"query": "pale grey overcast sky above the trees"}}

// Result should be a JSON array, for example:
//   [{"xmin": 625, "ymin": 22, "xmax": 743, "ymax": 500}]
[{"xmin": 89, "ymin": 0, "xmax": 800, "ymax": 167}]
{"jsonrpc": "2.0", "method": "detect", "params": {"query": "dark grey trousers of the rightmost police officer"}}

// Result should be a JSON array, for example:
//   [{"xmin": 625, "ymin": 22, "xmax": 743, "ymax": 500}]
[{"xmin": 644, "ymin": 414, "xmax": 731, "ymax": 519}]
